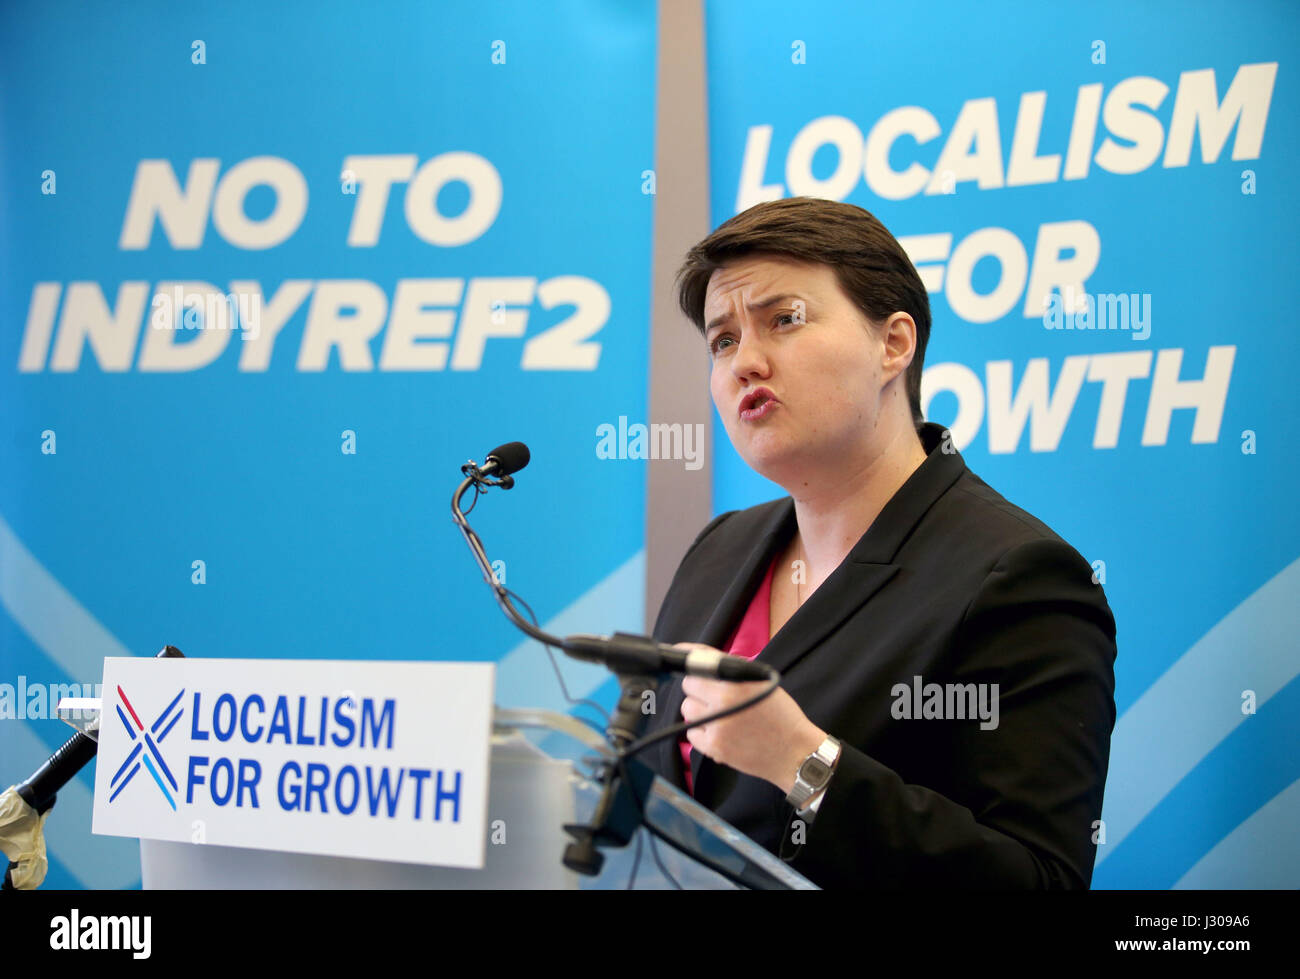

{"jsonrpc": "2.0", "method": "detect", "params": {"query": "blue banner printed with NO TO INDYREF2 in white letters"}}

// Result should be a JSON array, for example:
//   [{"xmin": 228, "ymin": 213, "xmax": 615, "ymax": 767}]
[{"xmin": 0, "ymin": 0, "xmax": 657, "ymax": 888}]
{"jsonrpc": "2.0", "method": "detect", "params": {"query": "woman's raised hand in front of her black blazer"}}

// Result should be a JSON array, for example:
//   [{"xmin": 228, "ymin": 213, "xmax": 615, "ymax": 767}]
[{"xmin": 676, "ymin": 642, "xmax": 826, "ymax": 794}]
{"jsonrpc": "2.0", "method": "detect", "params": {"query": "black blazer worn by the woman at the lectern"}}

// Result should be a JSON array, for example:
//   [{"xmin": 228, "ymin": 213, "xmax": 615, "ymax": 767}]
[{"xmin": 645, "ymin": 424, "xmax": 1115, "ymax": 888}]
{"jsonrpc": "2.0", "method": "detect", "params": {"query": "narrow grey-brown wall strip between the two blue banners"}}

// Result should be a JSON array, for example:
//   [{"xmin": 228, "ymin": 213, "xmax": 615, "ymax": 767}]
[{"xmin": 646, "ymin": 0, "xmax": 712, "ymax": 632}]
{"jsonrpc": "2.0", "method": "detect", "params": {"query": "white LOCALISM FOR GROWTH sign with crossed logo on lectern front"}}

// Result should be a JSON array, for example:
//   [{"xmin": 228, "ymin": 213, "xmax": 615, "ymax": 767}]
[{"xmin": 91, "ymin": 657, "xmax": 494, "ymax": 868}]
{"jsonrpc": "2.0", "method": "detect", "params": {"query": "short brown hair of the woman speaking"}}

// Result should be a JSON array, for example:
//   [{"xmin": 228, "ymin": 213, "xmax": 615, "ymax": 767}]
[{"xmin": 677, "ymin": 198, "xmax": 930, "ymax": 429}]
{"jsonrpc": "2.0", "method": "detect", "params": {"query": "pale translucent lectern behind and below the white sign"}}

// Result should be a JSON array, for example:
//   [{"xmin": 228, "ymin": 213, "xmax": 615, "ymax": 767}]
[{"xmin": 60, "ymin": 701, "xmax": 815, "ymax": 889}]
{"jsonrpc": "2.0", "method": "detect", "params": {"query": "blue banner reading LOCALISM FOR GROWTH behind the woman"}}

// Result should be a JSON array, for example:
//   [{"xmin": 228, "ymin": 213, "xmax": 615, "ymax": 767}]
[{"xmin": 706, "ymin": 0, "xmax": 1300, "ymax": 888}]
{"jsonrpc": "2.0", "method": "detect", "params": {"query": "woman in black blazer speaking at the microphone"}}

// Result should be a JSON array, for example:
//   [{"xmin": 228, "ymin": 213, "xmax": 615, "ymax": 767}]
[{"xmin": 646, "ymin": 198, "xmax": 1115, "ymax": 888}]
